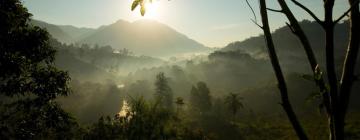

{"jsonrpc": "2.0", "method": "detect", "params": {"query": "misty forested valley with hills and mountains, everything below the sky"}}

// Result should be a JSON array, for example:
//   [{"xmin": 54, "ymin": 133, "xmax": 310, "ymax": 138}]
[{"xmin": 0, "ymin": 0, "xmax": 360, "ymax": 140}]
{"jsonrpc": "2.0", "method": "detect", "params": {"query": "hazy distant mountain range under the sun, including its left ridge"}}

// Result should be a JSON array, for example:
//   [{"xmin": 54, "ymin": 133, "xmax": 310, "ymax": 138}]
[{"xmin": 31, "ymin": 20, "xmax": 211, "ymax": 57}]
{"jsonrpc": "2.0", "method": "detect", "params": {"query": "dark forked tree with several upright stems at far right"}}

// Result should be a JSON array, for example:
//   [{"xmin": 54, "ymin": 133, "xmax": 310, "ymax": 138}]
[{"xmin": 292, "ymin": 0, "xmax": 360, "ymax": 140}]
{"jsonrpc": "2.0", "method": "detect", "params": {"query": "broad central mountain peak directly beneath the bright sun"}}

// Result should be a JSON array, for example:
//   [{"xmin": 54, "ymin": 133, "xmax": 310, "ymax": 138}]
[{"xmin": 78, "ymin": 20, "xmax": 209, "ymax": 57}]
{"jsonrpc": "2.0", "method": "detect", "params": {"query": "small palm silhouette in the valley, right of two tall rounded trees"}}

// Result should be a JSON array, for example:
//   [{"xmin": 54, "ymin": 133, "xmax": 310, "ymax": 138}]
[{"xmin": 225, "ymin": 93, "xmax": 244, "ymax": 118}]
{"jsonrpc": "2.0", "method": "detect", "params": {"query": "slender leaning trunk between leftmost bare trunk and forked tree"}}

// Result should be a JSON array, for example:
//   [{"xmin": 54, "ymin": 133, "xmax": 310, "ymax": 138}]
[{"xmin": 278, "ymin": 0, "xmax": 335, "ymax": 138}]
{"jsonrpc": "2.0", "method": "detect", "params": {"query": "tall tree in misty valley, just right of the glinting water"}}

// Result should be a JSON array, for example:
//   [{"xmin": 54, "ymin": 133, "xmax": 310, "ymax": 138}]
[{"xmin": 155, "ymin": 72, "xmax": 173, "ymax": 110}]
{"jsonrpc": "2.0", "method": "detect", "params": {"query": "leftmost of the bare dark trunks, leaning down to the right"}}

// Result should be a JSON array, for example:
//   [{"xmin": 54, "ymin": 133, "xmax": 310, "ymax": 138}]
[{"xmin": 260, "ymin": 0, "xmax": 308, "ymax": 140}]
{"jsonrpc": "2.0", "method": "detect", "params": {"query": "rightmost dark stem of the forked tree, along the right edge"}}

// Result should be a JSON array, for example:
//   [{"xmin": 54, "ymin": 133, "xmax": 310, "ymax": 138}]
[{"xmin": 337, "ymin": 0, "xmax": 360, "ymax": 137}]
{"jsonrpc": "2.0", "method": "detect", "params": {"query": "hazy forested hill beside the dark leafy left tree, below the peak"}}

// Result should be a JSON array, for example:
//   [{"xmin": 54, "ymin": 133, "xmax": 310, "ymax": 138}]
[{"xmin": 50, "ymin": 40, "xmax": 163, "ymax": 77}]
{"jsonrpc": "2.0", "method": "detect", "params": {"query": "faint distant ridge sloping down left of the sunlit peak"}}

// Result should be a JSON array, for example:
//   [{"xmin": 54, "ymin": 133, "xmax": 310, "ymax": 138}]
[{"xmin": 30, "ymin": 19, "xmax": 74, "ymax": 43}]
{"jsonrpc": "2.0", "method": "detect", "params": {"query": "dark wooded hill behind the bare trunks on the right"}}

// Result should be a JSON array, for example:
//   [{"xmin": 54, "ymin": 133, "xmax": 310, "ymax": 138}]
[{"xmin": 221, "ymin": 20, "xmax": 354, "ymax": 72}]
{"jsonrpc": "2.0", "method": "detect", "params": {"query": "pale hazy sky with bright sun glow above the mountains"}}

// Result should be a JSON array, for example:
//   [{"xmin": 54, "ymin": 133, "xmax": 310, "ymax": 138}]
[{"xmin": 23, "ymin": 0, "xmax": 348, "ymax": 47}]
